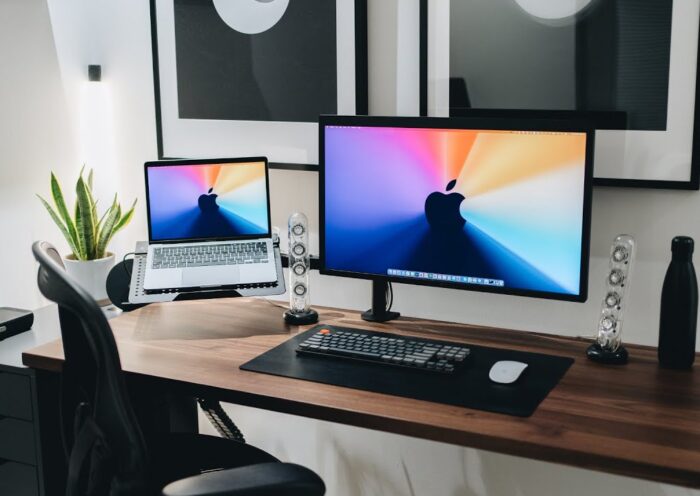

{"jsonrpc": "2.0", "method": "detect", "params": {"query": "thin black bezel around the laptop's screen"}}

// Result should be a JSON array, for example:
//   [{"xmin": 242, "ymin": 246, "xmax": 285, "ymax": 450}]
[{"xmin": 143, "ymin": 157, "xmax": 272, "ymax": 244}]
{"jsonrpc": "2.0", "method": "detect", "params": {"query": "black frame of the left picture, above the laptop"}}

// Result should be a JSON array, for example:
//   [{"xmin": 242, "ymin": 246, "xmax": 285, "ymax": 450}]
[{"xmin": 149, "ymin": 0, "xmax": 369, "ymax": 171}]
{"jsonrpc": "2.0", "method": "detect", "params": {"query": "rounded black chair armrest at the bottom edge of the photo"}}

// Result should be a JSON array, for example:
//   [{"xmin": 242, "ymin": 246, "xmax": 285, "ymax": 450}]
[{"xmin": 163, "ymin": 463, "xmax": 326, "ymax": 496}]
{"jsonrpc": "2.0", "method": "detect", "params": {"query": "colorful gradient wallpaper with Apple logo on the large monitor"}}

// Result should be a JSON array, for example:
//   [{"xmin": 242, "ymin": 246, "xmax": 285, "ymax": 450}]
[{"xmin": 324, "ymin": 126, "xmax": 586, "ymax": 295}]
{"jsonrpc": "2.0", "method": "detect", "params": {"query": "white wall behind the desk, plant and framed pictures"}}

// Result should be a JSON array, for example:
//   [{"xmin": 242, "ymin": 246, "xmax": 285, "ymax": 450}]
[{"xmin": 0, "ymin": 0, "xmax": 700, "ymax": 496}]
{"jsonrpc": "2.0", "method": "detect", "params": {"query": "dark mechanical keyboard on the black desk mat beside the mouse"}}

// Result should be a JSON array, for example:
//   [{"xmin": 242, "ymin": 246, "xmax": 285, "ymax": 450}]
[{"xmin": 296, "ymin": 326, "xmax": 471, "ymax": 374}]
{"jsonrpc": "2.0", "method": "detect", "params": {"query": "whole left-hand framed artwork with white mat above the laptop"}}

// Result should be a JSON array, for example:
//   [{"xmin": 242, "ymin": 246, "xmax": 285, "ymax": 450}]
[{"xmin": 151, "ymin": 0, "xmax": 367, "ymax": 168}]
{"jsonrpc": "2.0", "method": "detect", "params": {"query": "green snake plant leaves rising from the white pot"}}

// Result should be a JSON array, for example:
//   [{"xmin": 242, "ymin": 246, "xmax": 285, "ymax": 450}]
[{"xmin": 37, "ymin": 170, "xmax": 136, "ymax": 260}]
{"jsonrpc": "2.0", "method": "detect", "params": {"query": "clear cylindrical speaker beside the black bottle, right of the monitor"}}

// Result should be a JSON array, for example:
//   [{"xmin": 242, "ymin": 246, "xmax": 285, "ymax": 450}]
[{"xmin": 587, "ymin": 234, "xmax": 636, "ymax": 363}]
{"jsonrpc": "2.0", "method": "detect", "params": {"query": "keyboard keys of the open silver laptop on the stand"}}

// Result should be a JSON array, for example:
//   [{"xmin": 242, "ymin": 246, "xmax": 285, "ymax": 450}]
[{"xmin": 151, "ymin": 241, "xmax": 269, "ymax": 269}]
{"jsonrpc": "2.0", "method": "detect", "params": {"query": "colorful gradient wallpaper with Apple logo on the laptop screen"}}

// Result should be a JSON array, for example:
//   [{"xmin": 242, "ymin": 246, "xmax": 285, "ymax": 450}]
[{"xmin": 147, "ymin": 162, "xmax": 269, "ymax": 241}]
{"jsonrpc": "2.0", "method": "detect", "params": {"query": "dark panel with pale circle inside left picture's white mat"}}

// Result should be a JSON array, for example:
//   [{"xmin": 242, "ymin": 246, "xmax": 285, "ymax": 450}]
[{"xmin": 175, "ymin": 0, "xmax": 337, "ymax": 122}]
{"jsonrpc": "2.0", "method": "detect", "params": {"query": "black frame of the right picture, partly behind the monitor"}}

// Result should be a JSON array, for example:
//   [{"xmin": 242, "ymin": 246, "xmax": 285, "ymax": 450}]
[{"xmin": 419, "ymin": 0, "xmax": 700, "ymax": 191}]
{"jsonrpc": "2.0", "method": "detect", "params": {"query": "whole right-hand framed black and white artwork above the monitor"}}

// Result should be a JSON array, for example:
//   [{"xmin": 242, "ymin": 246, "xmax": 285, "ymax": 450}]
[{"xmin": 422, "ymin": 0, "xmax": 700, "ymax": 189}]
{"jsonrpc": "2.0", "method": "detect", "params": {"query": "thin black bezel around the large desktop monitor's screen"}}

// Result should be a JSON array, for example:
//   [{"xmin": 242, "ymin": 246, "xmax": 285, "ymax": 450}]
[{"xmin": 318, "ymin": 115, "xmax": 595, "ymax": 303}]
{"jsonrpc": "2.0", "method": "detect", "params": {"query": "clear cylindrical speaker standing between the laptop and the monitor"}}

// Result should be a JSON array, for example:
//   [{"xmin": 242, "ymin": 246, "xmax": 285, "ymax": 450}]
[{"xmin": 284, "ymin": 212, "xmax": 318, "ymax": 325}]
